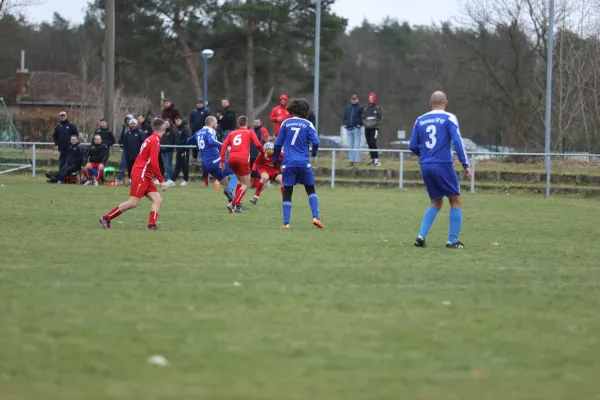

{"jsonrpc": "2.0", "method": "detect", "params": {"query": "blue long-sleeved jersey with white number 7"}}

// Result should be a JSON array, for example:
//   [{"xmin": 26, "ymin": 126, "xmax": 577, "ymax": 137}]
[{"xmin": 275, "ymin": 117, "xmax": 319, "ymax": 167}]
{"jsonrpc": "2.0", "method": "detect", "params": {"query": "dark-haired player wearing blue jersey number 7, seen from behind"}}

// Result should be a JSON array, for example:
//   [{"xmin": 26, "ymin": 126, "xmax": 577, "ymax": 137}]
[{"xmin": 273, "ymin": 99, "xmax": 325, "ymax": 229}]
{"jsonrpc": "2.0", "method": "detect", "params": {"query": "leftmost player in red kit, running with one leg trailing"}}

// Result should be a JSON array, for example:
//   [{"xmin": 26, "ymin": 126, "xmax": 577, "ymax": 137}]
[{"xmin": 100, "ymin": 118, "xmax": 167, "ymax": 231}]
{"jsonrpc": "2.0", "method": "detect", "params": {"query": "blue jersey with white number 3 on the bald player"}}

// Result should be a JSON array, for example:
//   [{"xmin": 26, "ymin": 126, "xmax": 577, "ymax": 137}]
[{"xmin": 410, "ymin": 110, "xmax": 469, "ymax": 168}]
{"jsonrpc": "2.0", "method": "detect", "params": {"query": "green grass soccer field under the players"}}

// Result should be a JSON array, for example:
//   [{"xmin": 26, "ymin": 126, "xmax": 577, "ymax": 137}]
[{"xmin": 0, "ymin": 176, "xmax": 600, "ymax": 400}]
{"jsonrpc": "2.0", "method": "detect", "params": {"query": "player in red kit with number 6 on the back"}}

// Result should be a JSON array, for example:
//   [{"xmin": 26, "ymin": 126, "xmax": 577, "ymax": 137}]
[{"xmin": 221, "ymin": 115, "xmax": 264, "ymax": 213}]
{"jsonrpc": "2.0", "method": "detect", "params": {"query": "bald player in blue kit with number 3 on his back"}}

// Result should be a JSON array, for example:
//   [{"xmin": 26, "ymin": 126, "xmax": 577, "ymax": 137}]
[{"xmin": 410, "ymin": 91, "xmax": 471, "ymax": 249}]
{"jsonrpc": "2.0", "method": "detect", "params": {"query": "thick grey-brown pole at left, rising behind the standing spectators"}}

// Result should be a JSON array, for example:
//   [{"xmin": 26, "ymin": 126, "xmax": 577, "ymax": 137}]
[{"xmin": 104, "ymin": 0, "xmax": 115, "ymax": 132}]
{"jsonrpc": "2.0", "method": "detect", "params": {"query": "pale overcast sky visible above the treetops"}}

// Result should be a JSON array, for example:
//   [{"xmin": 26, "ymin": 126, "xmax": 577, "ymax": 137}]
[{"xmin": 25, "ymin": 0, "xmax": 459, "ymax": 27}]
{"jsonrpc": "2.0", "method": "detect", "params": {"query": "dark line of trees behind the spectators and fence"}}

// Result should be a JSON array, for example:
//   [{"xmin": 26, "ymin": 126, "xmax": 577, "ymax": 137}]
[{"xmin": 0, "ymin": 0, "xmax": 600, "ymax": 152}]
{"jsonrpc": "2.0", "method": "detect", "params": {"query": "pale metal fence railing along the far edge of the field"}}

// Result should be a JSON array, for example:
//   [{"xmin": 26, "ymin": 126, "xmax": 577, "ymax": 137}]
[{"xmin": 0, "ymin": 142, "xmax": 600, "ymax": 193}]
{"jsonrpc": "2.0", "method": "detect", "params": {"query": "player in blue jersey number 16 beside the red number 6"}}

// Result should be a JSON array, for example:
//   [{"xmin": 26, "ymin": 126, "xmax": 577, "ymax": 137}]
[{"xmin": 186, "ymin": 116, "xmax": 233, "ymax": 202}]
